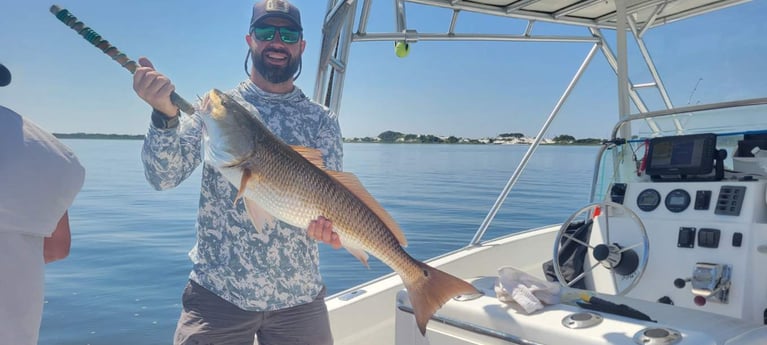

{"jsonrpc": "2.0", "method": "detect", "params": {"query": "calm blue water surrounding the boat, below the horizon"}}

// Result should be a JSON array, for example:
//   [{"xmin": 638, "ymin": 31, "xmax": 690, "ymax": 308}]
[{"xmin": 40, "ymin": 140, "xmax": 597, "ymax": 345}]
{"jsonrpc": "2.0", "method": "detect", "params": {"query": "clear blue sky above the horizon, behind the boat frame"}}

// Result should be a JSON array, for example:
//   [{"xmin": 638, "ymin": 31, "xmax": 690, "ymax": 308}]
[{"xmin": 0, "ymin": 0, "xmax": 767, "ymax": 138}]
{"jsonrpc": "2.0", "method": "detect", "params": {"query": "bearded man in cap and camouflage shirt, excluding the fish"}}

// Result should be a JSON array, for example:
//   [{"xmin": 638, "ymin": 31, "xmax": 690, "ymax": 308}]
[{"xmin": 133, "ymin": 0, "xmax": 343, "ymax": 345}]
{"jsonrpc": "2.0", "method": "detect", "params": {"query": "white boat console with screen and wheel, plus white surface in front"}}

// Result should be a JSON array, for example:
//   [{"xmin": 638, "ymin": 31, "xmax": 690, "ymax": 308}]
[{"xmin": 396, "ymin": 133, "xmax": 767, "ymax": 345}]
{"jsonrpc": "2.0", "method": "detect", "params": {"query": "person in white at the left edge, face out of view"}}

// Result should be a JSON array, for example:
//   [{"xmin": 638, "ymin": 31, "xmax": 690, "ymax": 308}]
[{"xmin": 0, "ymin": 64, "xmax": 85, "ymax": 345}]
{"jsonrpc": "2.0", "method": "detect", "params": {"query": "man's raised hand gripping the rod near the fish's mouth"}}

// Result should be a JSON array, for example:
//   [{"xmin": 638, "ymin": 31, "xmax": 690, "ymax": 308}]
[{"xmin": 133, "ymin": 57, "xmax": 178, "ymax": 117}]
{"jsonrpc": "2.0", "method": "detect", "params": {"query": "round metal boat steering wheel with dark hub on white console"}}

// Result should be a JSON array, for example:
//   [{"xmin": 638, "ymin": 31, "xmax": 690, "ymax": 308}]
[{"xmin": 552, "ymin": 201, "xmax": 650, "ymax": 295}]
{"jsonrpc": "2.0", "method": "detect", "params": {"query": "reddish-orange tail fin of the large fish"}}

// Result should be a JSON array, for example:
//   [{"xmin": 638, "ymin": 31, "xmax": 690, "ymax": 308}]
[{"xmin": 403, "ymin": 262, "xmax": 480, "ymax": 335}]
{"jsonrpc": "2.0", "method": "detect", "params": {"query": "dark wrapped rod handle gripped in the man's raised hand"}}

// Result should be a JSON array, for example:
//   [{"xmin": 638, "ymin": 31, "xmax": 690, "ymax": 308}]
[{"xmin": 51, "ymin": 5, "xmax": 194, "ymax": 115}]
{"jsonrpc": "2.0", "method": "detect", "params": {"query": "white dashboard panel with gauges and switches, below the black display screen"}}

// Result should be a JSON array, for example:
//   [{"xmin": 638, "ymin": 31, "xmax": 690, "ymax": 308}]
[{"xmin": 608, "ymin": 179, "xmax": 767, "ymax": 323}]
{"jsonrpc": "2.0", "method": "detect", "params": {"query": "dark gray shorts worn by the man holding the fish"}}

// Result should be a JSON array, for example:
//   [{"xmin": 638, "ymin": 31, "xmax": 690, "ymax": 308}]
[{"xmin": 173, "ymin": 280, "xmax": 333, "ymax": 345}]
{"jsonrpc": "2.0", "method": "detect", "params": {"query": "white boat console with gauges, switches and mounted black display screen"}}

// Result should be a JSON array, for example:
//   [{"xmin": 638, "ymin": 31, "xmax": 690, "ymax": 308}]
[{"xmin": 584, "ymin": 133, "xmax": 767, "ymax": 324}]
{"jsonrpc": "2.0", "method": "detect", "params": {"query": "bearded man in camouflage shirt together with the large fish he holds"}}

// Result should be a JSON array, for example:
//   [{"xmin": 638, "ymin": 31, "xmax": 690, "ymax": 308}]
[{"xmin": 134, "ymin": 0, "xmax": 477, "ymax": 344}]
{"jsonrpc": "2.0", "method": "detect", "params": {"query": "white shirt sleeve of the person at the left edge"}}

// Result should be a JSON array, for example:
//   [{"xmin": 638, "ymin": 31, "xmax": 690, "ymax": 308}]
[{"xmin": 0, "ymin": 106, "xmax": 85, "ymax": 236}]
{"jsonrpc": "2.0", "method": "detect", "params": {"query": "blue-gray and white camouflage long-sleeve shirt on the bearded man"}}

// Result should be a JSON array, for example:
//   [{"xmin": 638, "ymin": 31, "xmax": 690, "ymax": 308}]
[{"xmin": 142, "ymin": 80, "xmax": 343, "ymax": 311}]
